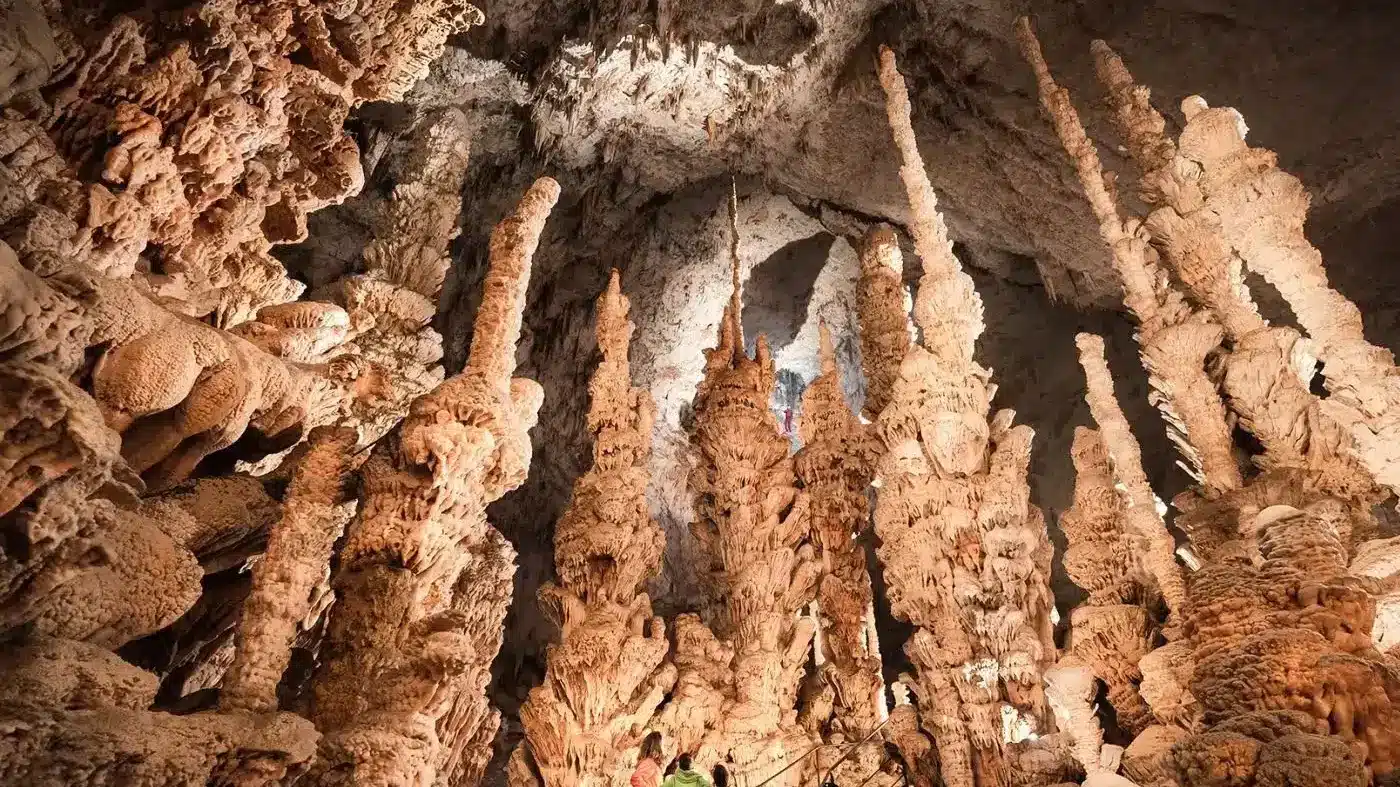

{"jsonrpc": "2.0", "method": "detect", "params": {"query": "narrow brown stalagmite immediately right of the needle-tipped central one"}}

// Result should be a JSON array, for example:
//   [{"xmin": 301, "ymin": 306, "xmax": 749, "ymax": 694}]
[{"xmin": 795, "ymin": 323, "xmax": 890, "ymax": 786}]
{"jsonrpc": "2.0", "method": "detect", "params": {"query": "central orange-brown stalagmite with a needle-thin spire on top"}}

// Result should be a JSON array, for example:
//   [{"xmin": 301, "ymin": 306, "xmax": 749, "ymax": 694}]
[{"xmin": 678, "ymin": 182, "xmax": 820, "ymax": 786}]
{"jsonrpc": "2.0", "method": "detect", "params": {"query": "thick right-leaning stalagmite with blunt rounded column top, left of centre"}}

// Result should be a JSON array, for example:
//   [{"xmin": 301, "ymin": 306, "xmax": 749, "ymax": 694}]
[{"xmin": 312, "ymin": 178, "xmax": 559, "ymax": 786}]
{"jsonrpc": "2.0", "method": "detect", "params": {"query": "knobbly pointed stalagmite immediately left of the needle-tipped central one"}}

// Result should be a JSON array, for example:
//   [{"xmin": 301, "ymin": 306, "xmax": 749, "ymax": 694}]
[{"xmin": 510, "ymin": 270, "xmax": 676, "ymax": 787}]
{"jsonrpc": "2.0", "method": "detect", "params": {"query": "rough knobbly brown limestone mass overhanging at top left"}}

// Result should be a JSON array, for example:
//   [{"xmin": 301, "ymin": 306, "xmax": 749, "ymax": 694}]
[{"xmin": 6, "ymin": 0, "xmax": 482, "ymax": 326}]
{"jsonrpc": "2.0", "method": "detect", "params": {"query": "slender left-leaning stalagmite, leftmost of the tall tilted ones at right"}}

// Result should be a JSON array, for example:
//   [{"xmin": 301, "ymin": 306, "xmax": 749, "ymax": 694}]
[{"xmin": 1016, "ymin": 18, "xmax": 1242, "ymax": 493}]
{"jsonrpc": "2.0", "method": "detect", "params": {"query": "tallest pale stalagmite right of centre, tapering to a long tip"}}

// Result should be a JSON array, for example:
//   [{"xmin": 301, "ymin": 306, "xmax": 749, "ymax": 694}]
[{"xmin": 875, "ymin": 49, "xmax": 1054, "ymax": 787}]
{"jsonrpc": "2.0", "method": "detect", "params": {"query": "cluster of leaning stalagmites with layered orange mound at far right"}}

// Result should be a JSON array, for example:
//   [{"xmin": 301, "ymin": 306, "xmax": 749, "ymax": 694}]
[{"xmin": 1018, "ymin": 22, "xmax": 1400, "ymax": 787}]
